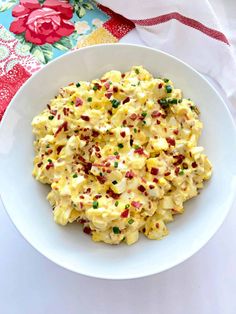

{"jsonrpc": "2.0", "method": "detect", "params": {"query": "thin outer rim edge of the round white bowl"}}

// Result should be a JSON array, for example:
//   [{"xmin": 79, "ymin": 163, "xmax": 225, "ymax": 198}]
[{"xmin": 0, "ymin": 43, "xmax": 236, "ymax": 280}]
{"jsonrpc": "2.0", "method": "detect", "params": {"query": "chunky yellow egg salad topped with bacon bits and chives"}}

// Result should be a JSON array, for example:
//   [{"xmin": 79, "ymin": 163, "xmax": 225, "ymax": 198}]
[{"xmin": 32, "ymin": 66, "xmax": 212, "ymax": 244}]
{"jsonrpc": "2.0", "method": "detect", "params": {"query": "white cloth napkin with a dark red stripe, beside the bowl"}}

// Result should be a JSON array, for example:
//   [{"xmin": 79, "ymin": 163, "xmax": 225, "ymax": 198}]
[{"xmin": 99, "ymin": 0, "xmax": 236, "ymax": 104}]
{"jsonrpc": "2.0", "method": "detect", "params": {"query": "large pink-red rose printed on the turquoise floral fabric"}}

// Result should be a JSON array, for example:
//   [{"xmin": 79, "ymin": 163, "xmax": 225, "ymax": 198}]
[{"xmin": 10, "ymin": 0, "xmax": 74, "ymax": 45}]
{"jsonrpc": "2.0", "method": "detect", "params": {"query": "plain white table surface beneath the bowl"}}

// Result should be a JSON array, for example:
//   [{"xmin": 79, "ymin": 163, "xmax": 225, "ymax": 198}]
[{"xmin": 0, "ymin": 0, "xmax": 236, "ymax": 314}]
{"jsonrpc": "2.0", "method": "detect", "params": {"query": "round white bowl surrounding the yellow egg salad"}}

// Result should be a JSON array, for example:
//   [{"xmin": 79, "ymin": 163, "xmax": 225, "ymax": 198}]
[{"xmin": 0, "ymin": 44, "xmax": 236, "ymax": 279}]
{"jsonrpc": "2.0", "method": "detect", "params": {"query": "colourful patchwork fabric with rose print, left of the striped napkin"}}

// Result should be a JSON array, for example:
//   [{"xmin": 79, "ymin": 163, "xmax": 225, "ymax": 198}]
[{"xmin": 0, "ymin": 0, "xmax": 134, "ymax": 120}]
